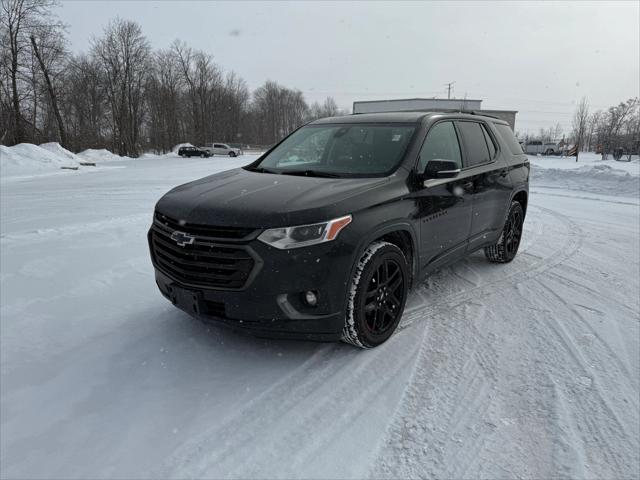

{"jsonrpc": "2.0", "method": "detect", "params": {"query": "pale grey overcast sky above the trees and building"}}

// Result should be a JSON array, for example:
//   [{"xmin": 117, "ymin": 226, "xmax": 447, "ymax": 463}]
[{"xmin": 58, "ymin": 0, "xmax": 640, "ymax": 132}]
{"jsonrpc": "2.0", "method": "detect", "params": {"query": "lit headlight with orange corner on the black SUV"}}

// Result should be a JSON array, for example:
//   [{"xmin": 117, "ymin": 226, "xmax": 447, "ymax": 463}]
[{"xmin": 258, "ymin": 215, "xmax": 351, "ymax": 250}]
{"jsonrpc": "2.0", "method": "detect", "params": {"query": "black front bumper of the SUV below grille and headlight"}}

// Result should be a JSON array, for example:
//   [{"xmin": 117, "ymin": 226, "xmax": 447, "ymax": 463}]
[{"xmin": 152, "ymin": 240, "xmax": 353, "ymax": 341}]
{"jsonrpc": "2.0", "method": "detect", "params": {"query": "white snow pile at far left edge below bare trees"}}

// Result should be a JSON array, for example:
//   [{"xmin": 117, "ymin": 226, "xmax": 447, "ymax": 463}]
[{"xmin": 0, "ymin": 143, "xmax": 80, "ymax": 178}]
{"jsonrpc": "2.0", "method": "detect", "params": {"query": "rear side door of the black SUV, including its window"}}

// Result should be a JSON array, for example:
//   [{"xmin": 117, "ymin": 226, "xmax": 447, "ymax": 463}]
[{"xmin": 458, "ymin": 120, "xmax": 512, "ymax": 251}]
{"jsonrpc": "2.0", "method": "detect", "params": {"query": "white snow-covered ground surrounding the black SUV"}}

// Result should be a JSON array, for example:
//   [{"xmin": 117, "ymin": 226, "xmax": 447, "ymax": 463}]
[{"xmin": 0, "ymin": 147, "xmax": 640, "ymax": 478}]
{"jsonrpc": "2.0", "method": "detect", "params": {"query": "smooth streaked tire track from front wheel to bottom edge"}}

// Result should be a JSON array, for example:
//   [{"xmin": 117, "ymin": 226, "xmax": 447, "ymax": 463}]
[{"xmin": 152, "ymin": 326, "xmax": 420, "ymax": 478}]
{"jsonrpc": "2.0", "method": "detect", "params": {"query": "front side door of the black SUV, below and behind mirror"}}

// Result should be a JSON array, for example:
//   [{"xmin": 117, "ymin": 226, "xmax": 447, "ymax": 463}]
[{"xmin": 414, "ymin": 121, "xmax": 473, "ymax": 271}]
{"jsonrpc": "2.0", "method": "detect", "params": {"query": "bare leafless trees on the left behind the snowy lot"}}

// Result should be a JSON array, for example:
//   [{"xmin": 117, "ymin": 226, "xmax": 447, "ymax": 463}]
[{"xmin": 0, "ymin": 0, "xmax": 344, "ymax": 156}]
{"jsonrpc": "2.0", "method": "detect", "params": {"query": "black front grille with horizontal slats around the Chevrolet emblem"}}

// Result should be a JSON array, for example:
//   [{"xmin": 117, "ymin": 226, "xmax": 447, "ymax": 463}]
[{"xmin": 149, "ymin": 214, "xmax": 256, "ymax": 289}]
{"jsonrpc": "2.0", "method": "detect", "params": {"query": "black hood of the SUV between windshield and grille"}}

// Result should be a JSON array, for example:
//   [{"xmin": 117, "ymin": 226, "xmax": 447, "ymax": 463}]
[{"xmin": 156, "ymin": 168, "xmax": 390, "ymax": 228}]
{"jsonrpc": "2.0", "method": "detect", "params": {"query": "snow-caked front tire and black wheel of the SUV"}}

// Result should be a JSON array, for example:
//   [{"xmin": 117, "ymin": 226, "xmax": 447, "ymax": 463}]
[{"xmin": 342, "ymin": 241, "xmax": 411, "ymax": 348}]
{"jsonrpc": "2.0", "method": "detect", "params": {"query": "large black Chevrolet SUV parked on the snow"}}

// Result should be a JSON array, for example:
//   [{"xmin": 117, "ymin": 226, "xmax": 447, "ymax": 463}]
[{"xmin": 149, "ymin": 112, "xmax": 529, "ymax": 348}]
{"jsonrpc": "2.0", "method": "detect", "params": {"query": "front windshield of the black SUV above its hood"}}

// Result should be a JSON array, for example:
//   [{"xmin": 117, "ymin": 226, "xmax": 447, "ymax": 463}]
[{"xmin": 253, "ymin": 124, "xmax": 416, "ymax": 176}]
